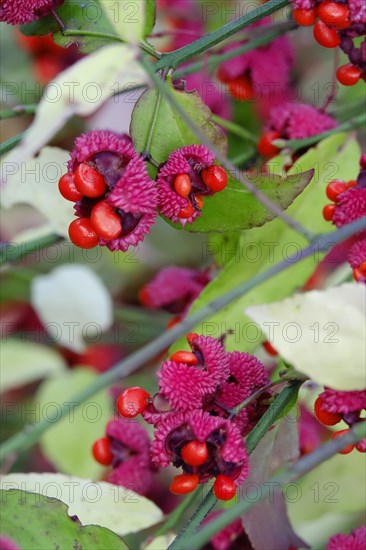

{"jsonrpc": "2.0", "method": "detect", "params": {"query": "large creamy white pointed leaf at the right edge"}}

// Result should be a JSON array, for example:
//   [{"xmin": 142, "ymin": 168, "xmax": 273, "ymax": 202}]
[{"xmin": 246, "ymin": 282, "xmax": 366, "ymax": 391}]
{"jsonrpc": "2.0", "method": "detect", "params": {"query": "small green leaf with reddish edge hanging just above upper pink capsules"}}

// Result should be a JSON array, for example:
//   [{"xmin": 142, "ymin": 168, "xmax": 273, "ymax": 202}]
[{"xmin": 130, "ymin": 88, "xmax": 227, "ymax": 163}]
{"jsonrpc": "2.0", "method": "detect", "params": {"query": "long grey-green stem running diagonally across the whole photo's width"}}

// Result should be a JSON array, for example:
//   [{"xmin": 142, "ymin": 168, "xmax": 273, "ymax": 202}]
[{"xmin": 0, "ymin": 216, "xmax": 366, "ymax": 460}]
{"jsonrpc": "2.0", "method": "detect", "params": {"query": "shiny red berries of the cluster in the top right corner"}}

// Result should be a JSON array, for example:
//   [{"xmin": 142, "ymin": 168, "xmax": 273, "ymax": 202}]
[{"xmin": 293, "ymin": 0, "xmax": 366, "ymax": 86}]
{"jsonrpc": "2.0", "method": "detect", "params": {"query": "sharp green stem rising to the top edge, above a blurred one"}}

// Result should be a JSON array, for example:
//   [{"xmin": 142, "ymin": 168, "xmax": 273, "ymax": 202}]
[{"xmin": 155, "ymin": 0, "xmax": 289, "ymax": 70}]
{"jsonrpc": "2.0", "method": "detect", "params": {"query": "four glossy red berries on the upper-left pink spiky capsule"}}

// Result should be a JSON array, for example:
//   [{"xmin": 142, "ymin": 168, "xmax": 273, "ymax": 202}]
[{"xmin": 59, "ymin": 162, "xmax": 122, "ymax": 248}]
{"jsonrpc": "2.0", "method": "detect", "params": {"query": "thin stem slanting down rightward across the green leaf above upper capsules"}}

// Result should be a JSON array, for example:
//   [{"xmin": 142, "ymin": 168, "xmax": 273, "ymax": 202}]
[{"xmin": 140, "ymin": 56, "xmax": 314, "ymax": 242}]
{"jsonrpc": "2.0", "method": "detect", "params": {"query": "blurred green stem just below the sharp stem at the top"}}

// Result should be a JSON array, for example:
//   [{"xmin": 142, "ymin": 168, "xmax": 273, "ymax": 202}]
[{"xmin": 174, "ymin": 21, "xmax": 297, "ymax": 78}]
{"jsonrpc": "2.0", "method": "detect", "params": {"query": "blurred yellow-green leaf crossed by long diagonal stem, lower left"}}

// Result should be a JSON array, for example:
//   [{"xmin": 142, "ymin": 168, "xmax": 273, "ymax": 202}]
[{"xmin": 35, "ymin": 368, "xmax": 112, "ymax": 478}]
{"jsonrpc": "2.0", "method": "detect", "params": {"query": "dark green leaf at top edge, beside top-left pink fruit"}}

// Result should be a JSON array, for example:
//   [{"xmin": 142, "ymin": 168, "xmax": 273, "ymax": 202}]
[{"xmin": 21, "ymin": 0, "xmax": 118, "ymax": 53}]
